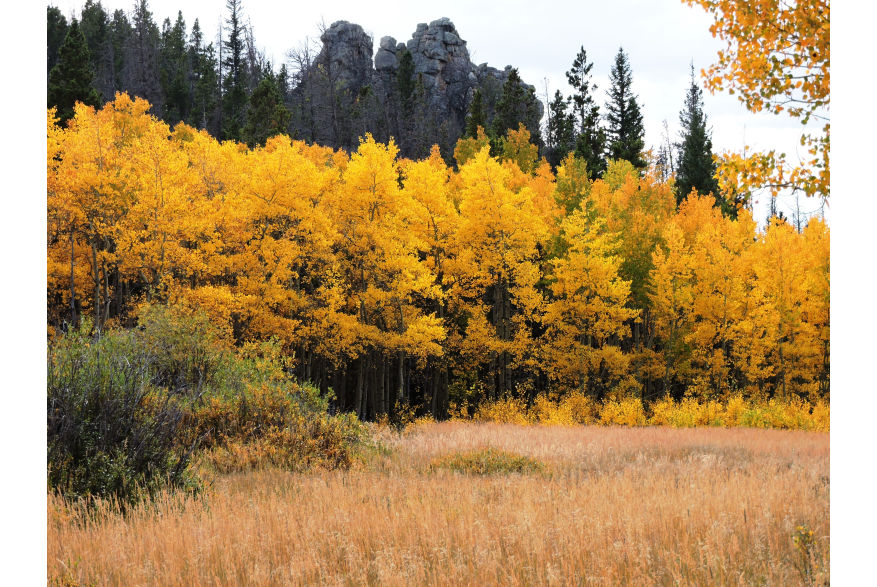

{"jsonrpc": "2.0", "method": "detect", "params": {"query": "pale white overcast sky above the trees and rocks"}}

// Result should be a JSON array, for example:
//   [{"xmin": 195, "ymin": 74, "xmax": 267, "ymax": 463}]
[{"xmin": 56, "ymin": 0, "xmax": 819, "ymax": 222}]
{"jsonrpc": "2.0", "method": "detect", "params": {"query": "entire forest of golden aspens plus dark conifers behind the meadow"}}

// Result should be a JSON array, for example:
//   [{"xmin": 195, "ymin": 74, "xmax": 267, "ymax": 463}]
[{"xmin": 46, "ymin": 0, "xmax": 830, "ymax": 419}]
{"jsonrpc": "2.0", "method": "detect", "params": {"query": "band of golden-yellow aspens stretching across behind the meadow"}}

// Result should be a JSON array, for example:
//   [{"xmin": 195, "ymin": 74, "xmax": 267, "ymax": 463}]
[{"xmin": 46, "ymin": 94, "xmax": 831, "ymax": 419}]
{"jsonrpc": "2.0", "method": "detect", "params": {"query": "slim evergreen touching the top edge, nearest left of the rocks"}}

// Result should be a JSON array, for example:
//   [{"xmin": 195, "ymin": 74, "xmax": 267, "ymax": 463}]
[{"xmin": 222, "ymin": 0, "xmax": 247, "ymax": 140}]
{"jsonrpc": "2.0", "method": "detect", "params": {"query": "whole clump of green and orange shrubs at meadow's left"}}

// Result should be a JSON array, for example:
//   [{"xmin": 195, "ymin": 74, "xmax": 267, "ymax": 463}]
[{"xmin": 46, "ymin": 306, "xmax": 364, "ymax": 505}]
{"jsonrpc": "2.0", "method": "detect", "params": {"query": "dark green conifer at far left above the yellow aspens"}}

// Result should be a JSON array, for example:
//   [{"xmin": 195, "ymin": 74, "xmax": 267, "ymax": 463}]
[{"xmin": 48, "ymin": 18, "xmax": 100, "ymax": 125}]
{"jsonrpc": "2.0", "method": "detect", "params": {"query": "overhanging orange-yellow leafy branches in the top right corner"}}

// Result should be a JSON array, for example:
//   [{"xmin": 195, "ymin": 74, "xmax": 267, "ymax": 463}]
[{"xmin": 683, "ymin": 0, "xmax": 831, "ymax": 200}]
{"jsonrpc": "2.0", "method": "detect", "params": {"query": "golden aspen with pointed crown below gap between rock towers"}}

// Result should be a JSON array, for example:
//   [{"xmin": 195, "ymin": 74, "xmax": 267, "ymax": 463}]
[{"xmin": 333, "ymin": 135, "xmax": 444, "ymax": 415}]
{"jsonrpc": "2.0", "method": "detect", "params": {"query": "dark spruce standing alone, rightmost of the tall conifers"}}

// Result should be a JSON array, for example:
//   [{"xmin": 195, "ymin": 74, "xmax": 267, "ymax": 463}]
[{"xmin": 676, "ymin": 63, "xmax": 729, "ymax": 213}]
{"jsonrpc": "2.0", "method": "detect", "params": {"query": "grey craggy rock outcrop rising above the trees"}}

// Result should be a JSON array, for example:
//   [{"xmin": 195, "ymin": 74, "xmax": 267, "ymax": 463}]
[{"xmin": 321, "ymin": 18, "xmax": 543, "ymax": 133}]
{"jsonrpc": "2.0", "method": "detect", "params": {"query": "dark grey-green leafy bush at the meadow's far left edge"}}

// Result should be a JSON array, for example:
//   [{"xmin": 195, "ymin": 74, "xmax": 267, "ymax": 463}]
[{"xmin": 46, "ymin": 333, "xmax": 197, "ymax": 503}]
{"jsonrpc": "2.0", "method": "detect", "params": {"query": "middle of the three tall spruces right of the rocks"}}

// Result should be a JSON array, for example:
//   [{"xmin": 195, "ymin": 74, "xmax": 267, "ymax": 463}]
[{"xmin": 606, "ymin": 48, "xmax": 647, "ymax": 169}]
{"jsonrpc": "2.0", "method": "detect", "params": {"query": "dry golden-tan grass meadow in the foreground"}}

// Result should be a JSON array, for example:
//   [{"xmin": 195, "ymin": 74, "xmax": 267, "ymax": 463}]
[{"xmin": 46, "ymin": 422, "xmax": 831, "ymax": 586}]
